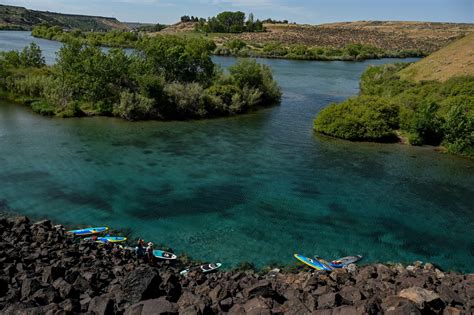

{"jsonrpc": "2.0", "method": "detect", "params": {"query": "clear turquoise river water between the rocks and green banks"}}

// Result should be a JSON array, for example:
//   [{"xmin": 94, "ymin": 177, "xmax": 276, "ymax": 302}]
[{"xmin": 0, "ymin": 33, "xmax": 474, "ymax": 272}]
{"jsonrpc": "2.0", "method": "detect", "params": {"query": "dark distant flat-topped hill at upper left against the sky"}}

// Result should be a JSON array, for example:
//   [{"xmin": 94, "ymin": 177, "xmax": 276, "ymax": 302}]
[{"xmin": 0, "ymin": 5, "xmax": 129, "ymax": 31}]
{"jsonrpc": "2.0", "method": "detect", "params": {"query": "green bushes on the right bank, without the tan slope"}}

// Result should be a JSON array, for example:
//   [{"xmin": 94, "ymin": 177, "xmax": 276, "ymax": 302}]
[{"xmin": 314, "ymin": 64, "xmax": 474, "ymax": 156}]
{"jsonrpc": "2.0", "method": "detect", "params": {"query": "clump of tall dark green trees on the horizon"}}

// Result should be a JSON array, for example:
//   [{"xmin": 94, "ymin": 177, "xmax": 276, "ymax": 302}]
[{"xmin": 196, "ymin": 11, "xmax": 265, "ymax": 33}]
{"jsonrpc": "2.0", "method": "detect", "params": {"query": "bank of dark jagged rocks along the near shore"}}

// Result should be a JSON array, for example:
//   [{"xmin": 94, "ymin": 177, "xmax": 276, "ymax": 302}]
[{"xmin": 0, "ymin": 217, "xmax": 474, "ymax": 315}]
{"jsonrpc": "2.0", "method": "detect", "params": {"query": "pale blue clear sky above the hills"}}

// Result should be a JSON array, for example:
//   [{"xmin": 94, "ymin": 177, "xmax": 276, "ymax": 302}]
[{"xmin": 0, "ymin": 0, "xmax": 474, "ymax": 24}]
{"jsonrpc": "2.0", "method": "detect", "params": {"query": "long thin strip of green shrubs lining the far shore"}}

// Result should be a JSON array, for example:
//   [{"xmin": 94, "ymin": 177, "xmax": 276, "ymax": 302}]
[{"xmin": 31, "ymin": 26, "xmax": 422, "ymax": 61}]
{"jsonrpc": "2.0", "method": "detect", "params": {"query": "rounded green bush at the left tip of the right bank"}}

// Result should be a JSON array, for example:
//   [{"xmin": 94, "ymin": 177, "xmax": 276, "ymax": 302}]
[{"xmin": 314, "ymin": 96, "xmax": 399, "ymax": 141}]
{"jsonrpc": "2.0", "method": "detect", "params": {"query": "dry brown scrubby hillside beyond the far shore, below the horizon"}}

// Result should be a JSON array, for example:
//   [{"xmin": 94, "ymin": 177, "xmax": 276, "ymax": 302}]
[{"xmin": 162, "ymin": 21, "xmax": 474, "ymax": 54}]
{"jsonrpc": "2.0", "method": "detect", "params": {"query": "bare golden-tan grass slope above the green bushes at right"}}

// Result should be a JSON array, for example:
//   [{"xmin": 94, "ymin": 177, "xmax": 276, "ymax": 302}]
[{"xmin": 400, "ymin": 33, "xmax": 474, "ymax": 82}]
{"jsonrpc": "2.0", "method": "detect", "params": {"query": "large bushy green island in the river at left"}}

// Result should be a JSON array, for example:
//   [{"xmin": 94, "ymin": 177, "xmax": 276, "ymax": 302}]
[{"xmin": 0, "ymin": 36, "xmax": 281, "ymax": 120}]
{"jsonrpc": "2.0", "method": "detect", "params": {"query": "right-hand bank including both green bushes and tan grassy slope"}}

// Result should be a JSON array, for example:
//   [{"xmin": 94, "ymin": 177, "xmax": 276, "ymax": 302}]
[{"xmin": 314, "ymin": 34, "xmax": 474, "ymax": 157}]
